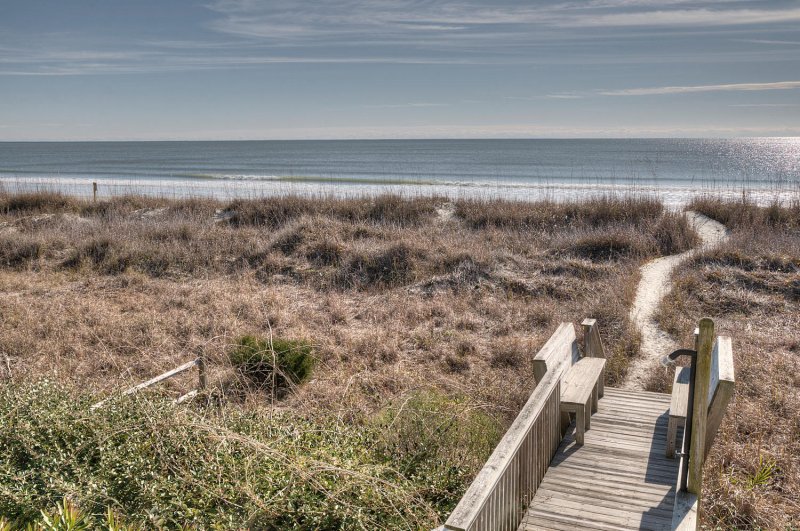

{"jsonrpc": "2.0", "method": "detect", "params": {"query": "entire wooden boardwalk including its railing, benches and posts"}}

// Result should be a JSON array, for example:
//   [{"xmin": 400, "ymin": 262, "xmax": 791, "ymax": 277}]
[{"xmin": 439, "ymin": 319, "xmax": 735, "ymax": 531}]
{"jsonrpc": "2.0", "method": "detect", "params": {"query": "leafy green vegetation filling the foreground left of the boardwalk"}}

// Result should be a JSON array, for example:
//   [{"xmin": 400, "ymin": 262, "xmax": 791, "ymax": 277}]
[{"xmin": 0, "ymin": 381, "xmax": 500, "ymax": 529}]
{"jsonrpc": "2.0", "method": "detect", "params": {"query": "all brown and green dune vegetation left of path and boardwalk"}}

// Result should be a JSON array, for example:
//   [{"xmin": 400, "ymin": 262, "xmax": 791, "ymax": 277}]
[{"xmin": 0, "ymin": 194, "xmax": 695, "ymax": 528}]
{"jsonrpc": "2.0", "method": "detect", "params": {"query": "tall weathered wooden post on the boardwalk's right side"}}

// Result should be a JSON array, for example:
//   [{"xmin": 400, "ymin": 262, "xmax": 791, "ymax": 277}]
[{"xmin": 686, "ymin": 318, "xmax": 714, "ymax": 497}]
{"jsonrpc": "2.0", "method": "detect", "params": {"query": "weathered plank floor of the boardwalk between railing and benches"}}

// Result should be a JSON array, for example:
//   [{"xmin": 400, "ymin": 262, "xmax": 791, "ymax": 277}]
[{"xmin": 519, "ymin": 387, "xmax": 679, "ymax": 531}]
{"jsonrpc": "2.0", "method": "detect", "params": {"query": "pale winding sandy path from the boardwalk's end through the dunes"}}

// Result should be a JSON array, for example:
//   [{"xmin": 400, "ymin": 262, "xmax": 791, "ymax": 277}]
[{"xmin": 623, "ymin": 211, "xmax": 728, "ymax": 389}]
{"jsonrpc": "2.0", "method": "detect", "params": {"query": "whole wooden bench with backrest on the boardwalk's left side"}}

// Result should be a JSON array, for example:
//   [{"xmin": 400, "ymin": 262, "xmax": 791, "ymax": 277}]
[{"xmin": 533, "ymin": 319, "xmax": 606, "ymax": 445}]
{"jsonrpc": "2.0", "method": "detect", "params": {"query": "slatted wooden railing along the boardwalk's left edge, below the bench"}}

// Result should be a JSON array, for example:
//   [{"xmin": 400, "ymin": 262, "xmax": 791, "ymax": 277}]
[{"xmin": 443, "ymin": 371, "xmax": 561, "ymax": 531}]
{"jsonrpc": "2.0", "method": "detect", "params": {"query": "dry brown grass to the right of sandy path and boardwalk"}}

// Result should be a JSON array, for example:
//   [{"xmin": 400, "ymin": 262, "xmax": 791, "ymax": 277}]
[{"xmin": 654, "ymin": 198, "xmax": 800, "ymax": 529}]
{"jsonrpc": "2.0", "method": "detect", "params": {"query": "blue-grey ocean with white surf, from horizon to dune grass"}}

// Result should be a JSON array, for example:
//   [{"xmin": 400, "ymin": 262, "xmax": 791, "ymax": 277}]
[{"xmin": 0, "ymin": 137, "xmax": 800, "ymax": 205}]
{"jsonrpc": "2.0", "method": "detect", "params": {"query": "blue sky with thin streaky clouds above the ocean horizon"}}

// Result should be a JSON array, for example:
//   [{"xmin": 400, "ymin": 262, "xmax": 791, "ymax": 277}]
[{"xmin": 0, "ymin": 0, "xmax": 800, "ymax": 140}]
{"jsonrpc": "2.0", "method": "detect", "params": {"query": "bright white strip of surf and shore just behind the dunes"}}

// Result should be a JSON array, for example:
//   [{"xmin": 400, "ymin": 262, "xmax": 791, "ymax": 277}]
[{"xmin": 0, "ymin": 176, "xmax": 800, "ymax": 209}]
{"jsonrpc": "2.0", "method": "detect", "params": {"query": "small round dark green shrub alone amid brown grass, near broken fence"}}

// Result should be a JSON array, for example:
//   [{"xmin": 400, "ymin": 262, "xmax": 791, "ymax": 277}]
[{"xmin": 229, "ymin": 336, "xmax": 315, "ymax": 388}]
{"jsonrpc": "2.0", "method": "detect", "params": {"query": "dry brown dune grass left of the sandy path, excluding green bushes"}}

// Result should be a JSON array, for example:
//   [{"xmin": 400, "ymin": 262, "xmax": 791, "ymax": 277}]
[{"xmin": 0, "ymin": 194, "xmax": 693, "ymax": 428}]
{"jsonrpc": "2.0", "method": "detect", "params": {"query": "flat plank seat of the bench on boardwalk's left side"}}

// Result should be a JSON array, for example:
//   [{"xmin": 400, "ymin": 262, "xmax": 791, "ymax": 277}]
[{"xmin": 561, "ymin": 358, "xmax": 606, "ymax": 445}]
